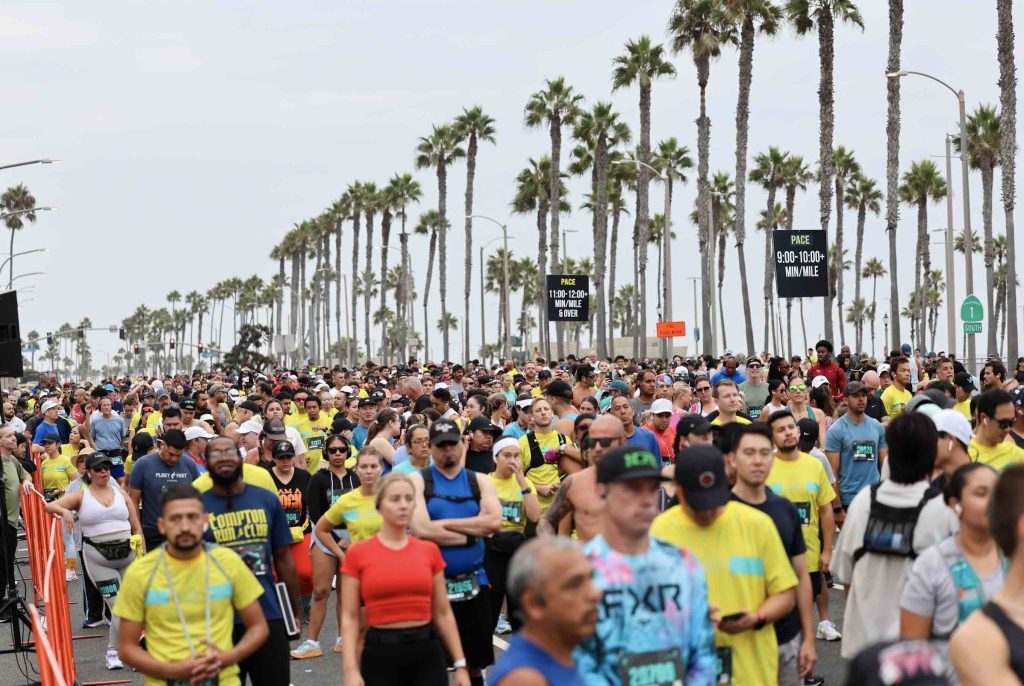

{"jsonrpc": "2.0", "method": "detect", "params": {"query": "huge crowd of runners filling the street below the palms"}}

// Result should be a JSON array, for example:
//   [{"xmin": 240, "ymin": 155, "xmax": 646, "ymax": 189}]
[{"xmin": 0, "ymin": 340, "xmax": 1024, "ymax": 686}]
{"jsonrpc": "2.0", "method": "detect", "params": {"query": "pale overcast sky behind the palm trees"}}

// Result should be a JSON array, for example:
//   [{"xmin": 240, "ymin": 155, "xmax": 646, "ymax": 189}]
[{"xmin": 0, "ymin": 0, "xmax": 1024, "ymax": 365}]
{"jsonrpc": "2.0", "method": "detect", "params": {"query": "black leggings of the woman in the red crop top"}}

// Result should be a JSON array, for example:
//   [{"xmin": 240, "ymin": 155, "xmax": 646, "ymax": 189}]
[{"xmin": 359, "ymin": 625, "xmax": 449, "ymax": 686}]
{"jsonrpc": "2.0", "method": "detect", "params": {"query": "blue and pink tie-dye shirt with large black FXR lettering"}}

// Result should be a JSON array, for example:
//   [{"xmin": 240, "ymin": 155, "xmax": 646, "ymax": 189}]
[{"xmin": 573, "ymin": 534, "xmax": 718, "ymax": 686}]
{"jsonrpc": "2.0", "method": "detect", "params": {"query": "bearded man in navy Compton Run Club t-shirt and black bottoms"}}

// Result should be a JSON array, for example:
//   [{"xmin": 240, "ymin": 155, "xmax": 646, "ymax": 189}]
[{"xmin": 203, "ymin": 436, "xmax": 302, "ymax": 686}]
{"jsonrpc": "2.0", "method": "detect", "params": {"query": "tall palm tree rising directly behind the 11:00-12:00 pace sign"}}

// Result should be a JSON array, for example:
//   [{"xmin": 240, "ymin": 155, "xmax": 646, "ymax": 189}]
[{"xmin": 525, "ymin": 77, "xmax": 583, "ymax": 358}]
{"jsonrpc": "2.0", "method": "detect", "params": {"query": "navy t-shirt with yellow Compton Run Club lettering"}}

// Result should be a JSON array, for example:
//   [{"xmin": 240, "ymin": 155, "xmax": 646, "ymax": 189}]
[{"xmin": 201, "ymin": 487, "xmax": 292, "ymax": 624}]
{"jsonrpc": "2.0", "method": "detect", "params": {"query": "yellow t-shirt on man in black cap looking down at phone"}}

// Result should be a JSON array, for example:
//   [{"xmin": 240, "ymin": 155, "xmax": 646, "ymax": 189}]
[{"xmin": 650, "ymin": 501, "xmax": 797, "ymax": 686}]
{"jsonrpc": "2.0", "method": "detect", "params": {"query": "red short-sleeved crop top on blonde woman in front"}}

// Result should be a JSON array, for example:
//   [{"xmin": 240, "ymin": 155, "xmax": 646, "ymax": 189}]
[{"xmin": 341, "ymin": 535, "xmax": 444, "ymax": 627}]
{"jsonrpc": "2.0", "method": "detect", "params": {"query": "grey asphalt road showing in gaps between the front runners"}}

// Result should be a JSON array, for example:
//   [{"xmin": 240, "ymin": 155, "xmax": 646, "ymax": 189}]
[{"xmin": 0, "ymin": 542, "xmax": 846, "ymax": 686}]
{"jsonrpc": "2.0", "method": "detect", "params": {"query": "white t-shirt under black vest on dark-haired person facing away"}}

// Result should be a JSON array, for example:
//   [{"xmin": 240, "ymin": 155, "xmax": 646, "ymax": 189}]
[{"xmin": 831, "ymin": 481, "xmax": 959, "ymax": 659}]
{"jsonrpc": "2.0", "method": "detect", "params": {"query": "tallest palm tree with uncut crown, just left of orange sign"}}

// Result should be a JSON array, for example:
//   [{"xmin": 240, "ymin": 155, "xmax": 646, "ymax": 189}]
[{"xmin": 611, "ymin": 36, "xmax": 676, "ymax": 355}]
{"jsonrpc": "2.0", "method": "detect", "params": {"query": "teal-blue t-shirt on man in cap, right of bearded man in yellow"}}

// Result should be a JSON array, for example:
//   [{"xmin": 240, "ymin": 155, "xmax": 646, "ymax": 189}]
[{"xmin": 825, "ymin": 415, "xmax": 888, "ymax": 507}]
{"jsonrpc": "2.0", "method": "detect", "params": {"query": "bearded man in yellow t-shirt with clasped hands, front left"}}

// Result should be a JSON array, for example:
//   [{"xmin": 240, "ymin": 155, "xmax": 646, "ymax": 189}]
[{"xmin": 114, "ymin": 484, "xmax": 270, "ymax": 686}]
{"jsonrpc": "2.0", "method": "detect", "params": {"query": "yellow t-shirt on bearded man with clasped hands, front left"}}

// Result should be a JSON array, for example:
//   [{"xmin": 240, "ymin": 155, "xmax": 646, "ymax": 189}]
[{"xmin": 114, "ymin": 546, "xmax": 263, "ymax": 686}]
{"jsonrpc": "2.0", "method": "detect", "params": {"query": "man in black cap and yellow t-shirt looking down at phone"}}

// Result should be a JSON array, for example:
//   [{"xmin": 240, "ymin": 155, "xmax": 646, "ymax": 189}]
[{"xmin": 650, "ymin": 445, "xmax": 797, "ymax": 686}]
